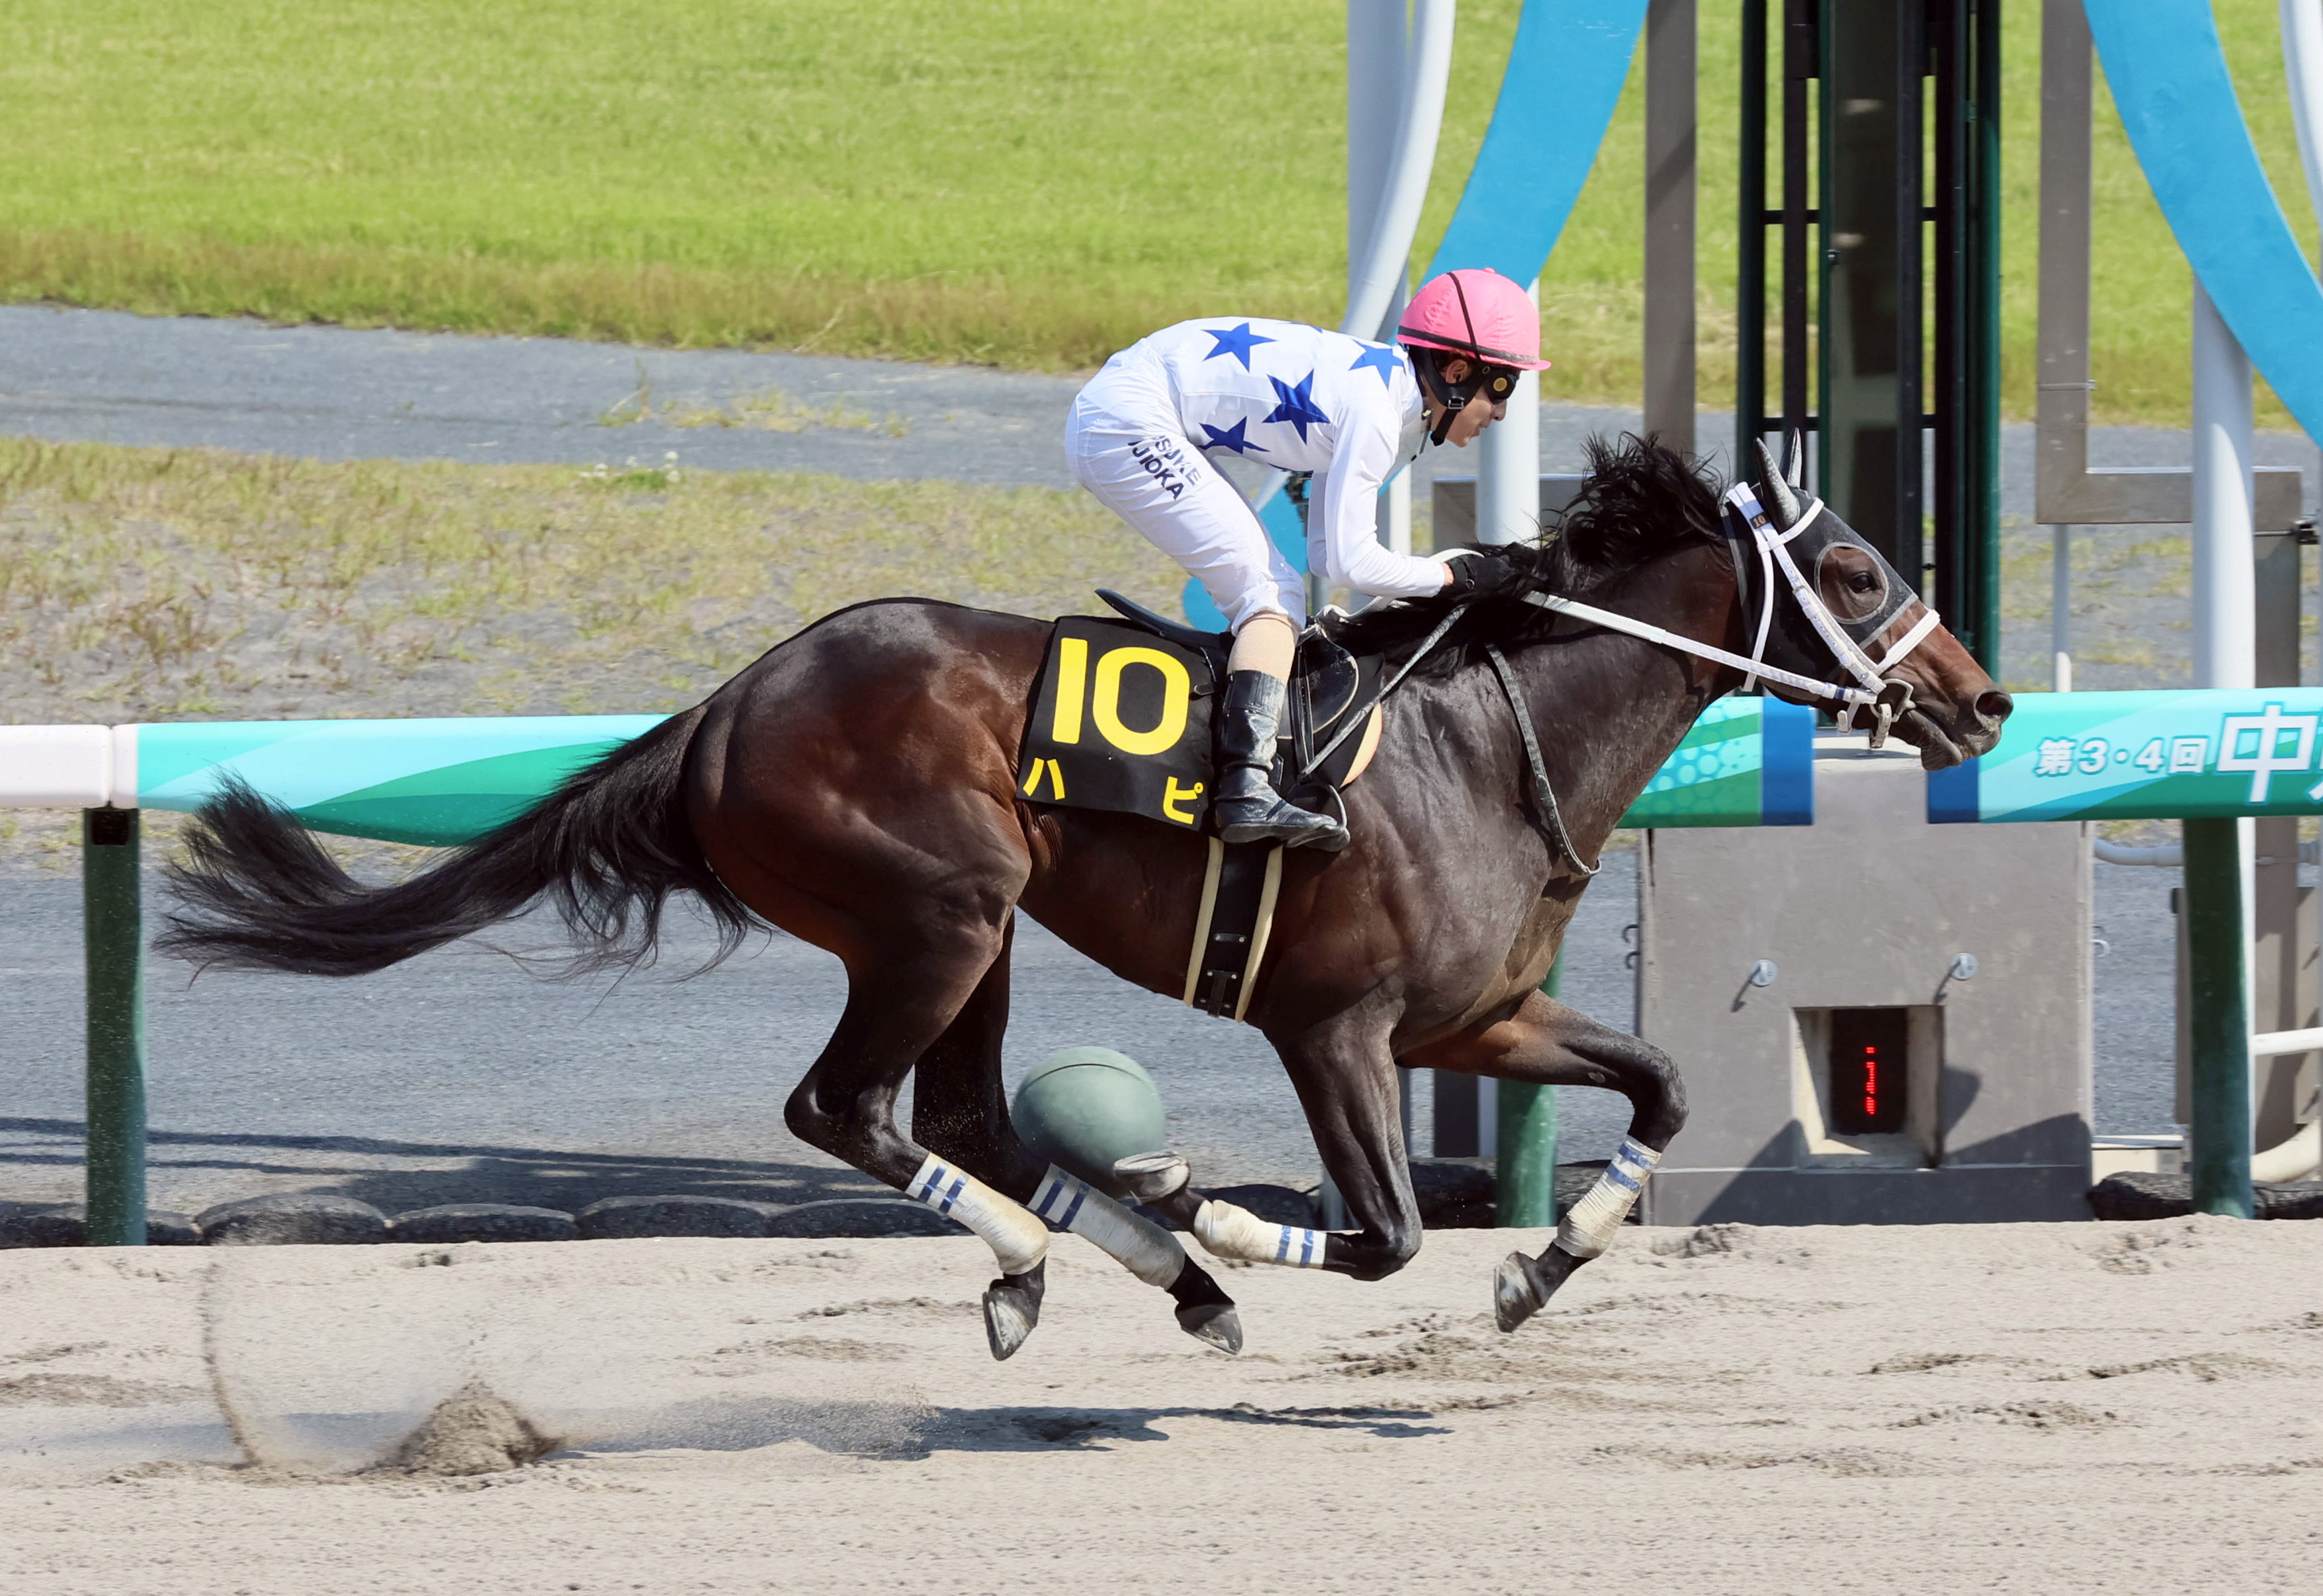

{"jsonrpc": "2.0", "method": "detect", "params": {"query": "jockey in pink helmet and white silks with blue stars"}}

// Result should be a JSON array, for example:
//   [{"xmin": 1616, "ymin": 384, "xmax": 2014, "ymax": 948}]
[{"xmin": 1064, "ymin": 267, "xmax": 1550, "ymax": 848}]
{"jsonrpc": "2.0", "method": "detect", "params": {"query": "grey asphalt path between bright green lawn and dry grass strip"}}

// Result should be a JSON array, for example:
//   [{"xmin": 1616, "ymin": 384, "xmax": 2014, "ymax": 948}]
[{"xmin": 0, "ymin": 307, "xmax": 2318, "ymax": 523}]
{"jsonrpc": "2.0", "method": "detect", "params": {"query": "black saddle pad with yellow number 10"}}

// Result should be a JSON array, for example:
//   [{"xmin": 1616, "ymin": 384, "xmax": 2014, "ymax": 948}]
[{"xmin": 1017, "ymin": 616, "xmax": 1215, "ymax": 832}]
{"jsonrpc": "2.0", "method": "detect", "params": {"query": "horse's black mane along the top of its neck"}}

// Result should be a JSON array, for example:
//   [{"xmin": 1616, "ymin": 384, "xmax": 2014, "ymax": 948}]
[{"xmin": 1333, "ymin": 432, "xmax": 1724, "ymax": 676}]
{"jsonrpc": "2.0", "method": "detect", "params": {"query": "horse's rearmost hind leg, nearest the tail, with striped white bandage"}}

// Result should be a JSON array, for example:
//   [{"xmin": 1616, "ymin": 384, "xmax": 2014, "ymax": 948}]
[{"xmin": 783, "ymin": 924, "xmax": 1048, "ymax": 1356}]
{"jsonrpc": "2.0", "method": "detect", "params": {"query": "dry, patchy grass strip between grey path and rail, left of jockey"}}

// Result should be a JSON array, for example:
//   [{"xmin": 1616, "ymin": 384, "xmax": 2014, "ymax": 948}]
[{"xmin": 0, "ymin": 439, "xmax": 1185, "ymax": 723}]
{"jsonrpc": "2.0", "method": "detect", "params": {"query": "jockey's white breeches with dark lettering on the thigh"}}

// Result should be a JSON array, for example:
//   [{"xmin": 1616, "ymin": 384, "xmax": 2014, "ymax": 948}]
[{"xmin": 1064, "ymin": 360, "xmax": 1306, "ymax": 630}]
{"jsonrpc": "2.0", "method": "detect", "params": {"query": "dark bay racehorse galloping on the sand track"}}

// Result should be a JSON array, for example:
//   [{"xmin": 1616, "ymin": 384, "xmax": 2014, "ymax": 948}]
[{"xmin": 163, "ymin": 439, "xmax": 2010, "ymax": 1356}]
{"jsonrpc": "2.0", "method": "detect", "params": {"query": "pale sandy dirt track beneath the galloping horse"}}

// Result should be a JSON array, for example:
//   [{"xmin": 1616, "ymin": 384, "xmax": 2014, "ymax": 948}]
[{"xmin": 0, "ymin": 1220, "xmax": 2323, "ymax": 1596}]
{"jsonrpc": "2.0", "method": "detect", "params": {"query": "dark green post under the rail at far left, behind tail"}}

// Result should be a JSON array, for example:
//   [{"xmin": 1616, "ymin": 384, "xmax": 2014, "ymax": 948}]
[{"xmin": 82, "ymin": 808, "xmax": 147, "ymax": 1248}]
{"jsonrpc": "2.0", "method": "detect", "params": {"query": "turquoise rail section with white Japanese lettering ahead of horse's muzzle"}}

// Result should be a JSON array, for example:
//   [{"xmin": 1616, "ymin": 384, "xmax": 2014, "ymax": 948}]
[{"xmin": 1928, "ymin": 688, "xmax": 2323, "ymax": 822}]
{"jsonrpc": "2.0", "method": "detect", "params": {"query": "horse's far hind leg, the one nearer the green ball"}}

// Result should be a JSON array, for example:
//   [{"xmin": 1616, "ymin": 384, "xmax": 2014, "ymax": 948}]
[{"xmin": 911, "ymin": 922, "xmax": 1243, "ymax": 1352}]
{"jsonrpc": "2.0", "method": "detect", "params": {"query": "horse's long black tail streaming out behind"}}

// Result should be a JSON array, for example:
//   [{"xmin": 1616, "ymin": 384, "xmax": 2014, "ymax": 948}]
[{"xmin": 156, "ymin": 706, "xmax": 755, "ymax": 976}]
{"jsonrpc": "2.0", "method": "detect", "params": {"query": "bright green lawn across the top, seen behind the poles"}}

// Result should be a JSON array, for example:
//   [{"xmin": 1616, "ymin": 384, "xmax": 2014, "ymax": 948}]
[{"xmin": 0, "ymin": 0, "xmax": 2314, "ymax": 423}]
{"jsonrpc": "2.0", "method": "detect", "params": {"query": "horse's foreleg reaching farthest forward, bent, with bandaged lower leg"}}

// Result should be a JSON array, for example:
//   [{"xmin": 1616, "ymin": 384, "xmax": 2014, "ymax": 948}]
[{"xmin": 1406, "ymin": 992, "xmax": 1686, "ymax": 1331}]
